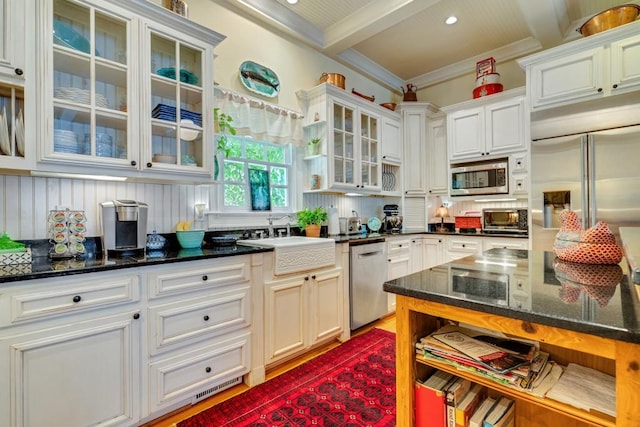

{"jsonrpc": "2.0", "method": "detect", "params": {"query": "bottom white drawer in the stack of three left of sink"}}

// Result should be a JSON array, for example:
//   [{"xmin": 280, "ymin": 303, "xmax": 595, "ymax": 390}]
[{"xmin": 149, "ymin": 333, "xmax": 251, "ymax": 411}]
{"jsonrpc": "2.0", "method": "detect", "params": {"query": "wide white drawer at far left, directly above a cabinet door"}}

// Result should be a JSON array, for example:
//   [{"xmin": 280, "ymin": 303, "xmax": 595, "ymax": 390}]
[{"xmin": 0, "ymin": 274, "xmax": 140, "ymax": 326}]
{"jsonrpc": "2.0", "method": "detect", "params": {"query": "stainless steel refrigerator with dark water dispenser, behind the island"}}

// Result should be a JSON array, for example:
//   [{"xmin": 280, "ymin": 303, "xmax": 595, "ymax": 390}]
[{"xmin": 530, "ymin": 123, "xmax": 640, "ymax": 251}]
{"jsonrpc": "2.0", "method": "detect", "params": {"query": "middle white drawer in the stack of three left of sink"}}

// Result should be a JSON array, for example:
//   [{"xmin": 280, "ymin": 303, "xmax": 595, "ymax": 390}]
[{"xmin": 148, "ymin": 286, "xmax": 251, "ymax": 355}]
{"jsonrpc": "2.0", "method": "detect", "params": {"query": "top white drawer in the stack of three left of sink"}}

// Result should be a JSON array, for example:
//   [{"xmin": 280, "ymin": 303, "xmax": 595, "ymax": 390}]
[{"xmin": 149, "ymin": 256, "xmax": 251, "ymax": 299}]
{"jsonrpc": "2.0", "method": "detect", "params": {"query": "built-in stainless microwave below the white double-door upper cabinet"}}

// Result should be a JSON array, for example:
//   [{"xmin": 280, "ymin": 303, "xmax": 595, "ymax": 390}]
[{"xmin": 451, "ymin": 159, "xmax": 509, "ymax": 196}]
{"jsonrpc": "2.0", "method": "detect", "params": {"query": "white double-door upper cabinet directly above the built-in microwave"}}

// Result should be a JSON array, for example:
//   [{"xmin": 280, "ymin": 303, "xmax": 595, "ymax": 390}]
[{"xmin": 443, "ymin": 88, "xmax": 527, "ymax": 161}]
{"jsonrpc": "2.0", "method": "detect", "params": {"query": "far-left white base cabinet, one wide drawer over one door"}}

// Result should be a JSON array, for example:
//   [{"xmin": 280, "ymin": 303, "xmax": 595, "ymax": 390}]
[{"xmin": 0, "ymin": 272, "xmax": 144, "ymax": 427}]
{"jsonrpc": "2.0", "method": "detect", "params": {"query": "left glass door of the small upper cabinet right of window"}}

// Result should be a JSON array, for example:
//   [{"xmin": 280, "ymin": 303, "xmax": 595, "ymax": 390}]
[{"xmin": 333, "ymin": 103, "xmax": 356, "ymax": 184}]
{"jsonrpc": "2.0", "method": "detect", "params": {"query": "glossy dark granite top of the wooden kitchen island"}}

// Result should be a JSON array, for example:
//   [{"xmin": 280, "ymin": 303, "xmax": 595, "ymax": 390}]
[{"xmin": 384, "ymin": 249, "xmax": 640, "ymax": 343}]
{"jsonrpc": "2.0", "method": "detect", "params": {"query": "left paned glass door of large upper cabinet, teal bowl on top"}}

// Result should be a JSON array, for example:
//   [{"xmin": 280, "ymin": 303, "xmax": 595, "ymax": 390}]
[{"xmin": 52, "ymin": 0, "xmax": 130, "ymax": 163}]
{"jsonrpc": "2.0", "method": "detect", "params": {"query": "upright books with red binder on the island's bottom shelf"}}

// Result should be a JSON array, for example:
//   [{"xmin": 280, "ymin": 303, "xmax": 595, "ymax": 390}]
[{"xmin": 415, "ymin": 371, "xmax": 515, "ymax": 427}]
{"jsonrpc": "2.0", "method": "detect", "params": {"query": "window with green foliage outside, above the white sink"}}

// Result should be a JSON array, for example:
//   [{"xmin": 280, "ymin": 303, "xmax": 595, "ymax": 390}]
[{"xmin": 218, "ymin": 136, "xmax": 292, "ymax": 211}]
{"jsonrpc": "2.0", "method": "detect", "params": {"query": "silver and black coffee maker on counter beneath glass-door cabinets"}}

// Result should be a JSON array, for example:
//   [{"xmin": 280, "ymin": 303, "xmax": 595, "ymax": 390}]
[{"xmin": 100, "ymin": 200, "xmax": 148, "ymax": 256}]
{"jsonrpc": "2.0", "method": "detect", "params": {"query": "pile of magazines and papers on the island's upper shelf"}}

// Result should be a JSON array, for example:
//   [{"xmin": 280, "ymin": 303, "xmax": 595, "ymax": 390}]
[{"xmin": 416, "ymin": 325, "xmax": 552, "ymax": 392}]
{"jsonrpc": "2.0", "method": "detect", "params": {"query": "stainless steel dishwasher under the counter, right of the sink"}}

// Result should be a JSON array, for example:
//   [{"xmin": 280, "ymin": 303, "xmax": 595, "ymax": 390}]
[{"xmin": 349, "ymin": 241, "xmax": 388, "ymax": 330}]
